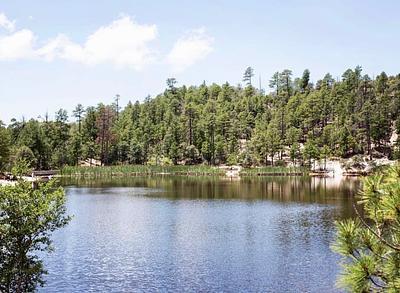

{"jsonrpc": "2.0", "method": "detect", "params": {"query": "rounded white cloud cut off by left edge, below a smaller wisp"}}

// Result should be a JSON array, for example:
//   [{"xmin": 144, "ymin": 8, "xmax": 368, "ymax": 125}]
[{"xmin": 0, "ymin": 29, "xmax": 35, "ymax": 60}]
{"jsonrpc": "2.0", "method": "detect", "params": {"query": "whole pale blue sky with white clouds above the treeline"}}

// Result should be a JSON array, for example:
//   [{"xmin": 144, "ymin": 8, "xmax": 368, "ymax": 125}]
[{"xmin": 0, "ymin": 0, "xmax": 400, "ymax": 123}]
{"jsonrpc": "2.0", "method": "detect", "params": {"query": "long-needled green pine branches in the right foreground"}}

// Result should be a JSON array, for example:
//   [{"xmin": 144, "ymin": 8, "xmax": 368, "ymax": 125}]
[{"xmin": 332, "ymin": 164, "xmax": 400, "ymax": 292}]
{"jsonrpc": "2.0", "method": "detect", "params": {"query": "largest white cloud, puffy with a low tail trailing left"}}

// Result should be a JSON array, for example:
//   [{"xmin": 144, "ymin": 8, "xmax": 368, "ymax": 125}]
[{"xmin": 38, "ymin": 16, "xmax": 157, "ymax": 69}]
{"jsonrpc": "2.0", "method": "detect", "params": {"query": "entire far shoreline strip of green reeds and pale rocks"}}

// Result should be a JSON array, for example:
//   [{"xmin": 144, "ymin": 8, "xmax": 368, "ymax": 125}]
[{"xmin": 0, "ymin": 159, "xmax": 395, "ymax": 186}]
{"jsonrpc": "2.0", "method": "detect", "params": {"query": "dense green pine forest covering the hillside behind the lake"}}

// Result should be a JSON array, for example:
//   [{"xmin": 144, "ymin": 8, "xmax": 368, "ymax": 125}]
[{"xmin": 0, "ymin": 66, "xmax": 400, "ymax": 169}]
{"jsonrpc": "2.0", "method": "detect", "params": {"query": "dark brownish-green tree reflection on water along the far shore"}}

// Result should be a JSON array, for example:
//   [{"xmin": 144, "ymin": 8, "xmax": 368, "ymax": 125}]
[{"xmin": 62, "ymin": 176, "xmax": 360, "ymax": 217}]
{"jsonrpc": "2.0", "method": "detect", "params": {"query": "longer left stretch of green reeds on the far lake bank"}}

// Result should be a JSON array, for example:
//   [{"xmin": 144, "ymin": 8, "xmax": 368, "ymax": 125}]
[{"xmin": 60, "ymin": 165, "xmax": 225, "ymax": 177}]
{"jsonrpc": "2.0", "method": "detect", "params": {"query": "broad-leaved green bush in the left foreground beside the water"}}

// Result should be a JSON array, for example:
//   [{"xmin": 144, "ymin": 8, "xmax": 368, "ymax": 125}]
[{"xmin": 0, "ymin": 181, "xmax": 70, "ymax": 292}]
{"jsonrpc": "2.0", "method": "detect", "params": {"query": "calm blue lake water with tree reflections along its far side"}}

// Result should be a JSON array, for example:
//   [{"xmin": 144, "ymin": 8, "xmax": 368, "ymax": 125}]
[{"xmin": 39, "ymin": 177, "xmax": 359, "ymax": 292}]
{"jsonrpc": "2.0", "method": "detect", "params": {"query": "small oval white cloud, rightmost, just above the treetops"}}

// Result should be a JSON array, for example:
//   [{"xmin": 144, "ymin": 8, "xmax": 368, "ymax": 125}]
[{"xmin": 167, "ymin": 28, "xmax": 213, "ymax": 72}]
